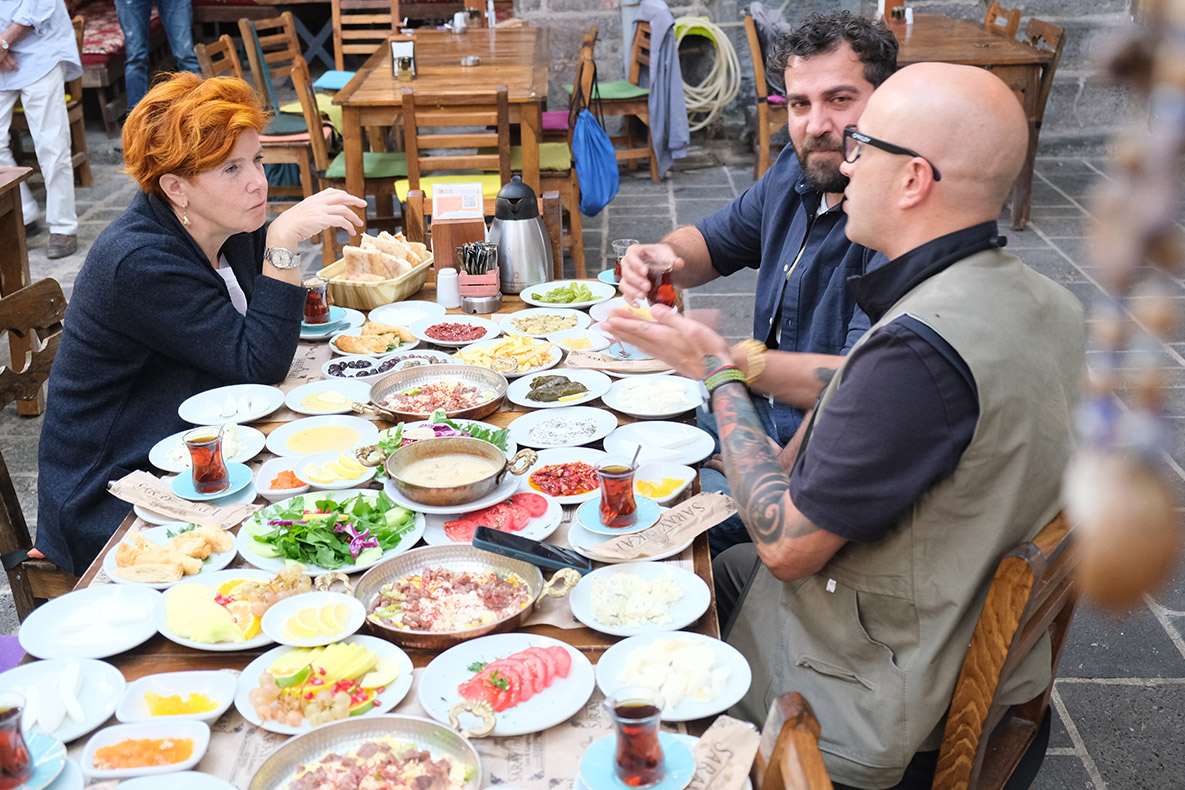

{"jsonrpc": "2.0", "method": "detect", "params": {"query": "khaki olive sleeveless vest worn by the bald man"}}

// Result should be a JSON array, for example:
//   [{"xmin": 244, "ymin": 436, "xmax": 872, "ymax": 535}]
[{"xmin": 729, "ymin": 249, "xmax": 1084, "ymax": 788}]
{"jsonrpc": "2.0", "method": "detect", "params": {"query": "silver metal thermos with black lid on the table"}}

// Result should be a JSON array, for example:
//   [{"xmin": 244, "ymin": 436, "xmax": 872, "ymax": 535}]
[{"xmin": 489, "ymin": 175, "xmax": 551, "ymax": 294}]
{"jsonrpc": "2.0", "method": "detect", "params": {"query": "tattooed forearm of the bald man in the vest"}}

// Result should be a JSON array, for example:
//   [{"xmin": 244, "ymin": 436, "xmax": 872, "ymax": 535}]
[{"xmin": 705, "ymin": 379, "xmax": 815, "ymax": 545}]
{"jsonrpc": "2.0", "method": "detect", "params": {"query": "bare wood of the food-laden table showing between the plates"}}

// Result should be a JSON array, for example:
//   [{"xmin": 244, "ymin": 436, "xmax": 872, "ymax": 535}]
[{"xmin": 76, "ymin": 284, "xmax": 719, "ymax": 682}]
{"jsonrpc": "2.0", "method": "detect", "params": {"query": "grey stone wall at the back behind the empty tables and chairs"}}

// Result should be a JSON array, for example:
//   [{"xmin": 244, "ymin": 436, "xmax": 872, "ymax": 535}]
[{"xmin": 515, "ymin": 0, "xmax": 1135, "ymax": 154}]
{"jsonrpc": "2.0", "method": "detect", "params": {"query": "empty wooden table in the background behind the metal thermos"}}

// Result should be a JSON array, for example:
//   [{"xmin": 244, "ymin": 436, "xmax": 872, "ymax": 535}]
[{"xmin": 333, "ymin": 27, "xmax": 550, "ymax": 240}]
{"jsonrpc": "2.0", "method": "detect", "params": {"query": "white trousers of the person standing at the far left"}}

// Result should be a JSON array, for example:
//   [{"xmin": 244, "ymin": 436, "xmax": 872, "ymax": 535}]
[{"xmin": 0, "ymin": 64, "xmax": 78, "ymax": 236}]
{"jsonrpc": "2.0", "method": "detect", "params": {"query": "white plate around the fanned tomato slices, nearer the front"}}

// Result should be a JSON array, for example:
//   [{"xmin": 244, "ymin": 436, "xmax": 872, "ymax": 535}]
[{"xmin": 418, "ymin": 634, "xmax": 594, "ymax": 738}]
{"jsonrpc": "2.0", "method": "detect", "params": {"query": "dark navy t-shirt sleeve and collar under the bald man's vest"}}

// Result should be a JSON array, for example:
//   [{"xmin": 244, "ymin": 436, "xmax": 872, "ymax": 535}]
[{"xmin": 790, "ymin": 221, "xmax": 1004, "ymax": 542}]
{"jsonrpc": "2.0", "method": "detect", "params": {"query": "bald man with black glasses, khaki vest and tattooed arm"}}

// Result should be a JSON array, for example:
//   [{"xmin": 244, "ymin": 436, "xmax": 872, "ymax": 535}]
[{"xmin": 606, "ymin": 63, "xmax": 1084, "ymax": 790}]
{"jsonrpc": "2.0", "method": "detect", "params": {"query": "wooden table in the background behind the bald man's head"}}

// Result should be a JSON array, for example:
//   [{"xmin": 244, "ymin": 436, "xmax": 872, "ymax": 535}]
[{"xmin": 889, "ymin": 14, "xmax": 1052, "ymax": 231}]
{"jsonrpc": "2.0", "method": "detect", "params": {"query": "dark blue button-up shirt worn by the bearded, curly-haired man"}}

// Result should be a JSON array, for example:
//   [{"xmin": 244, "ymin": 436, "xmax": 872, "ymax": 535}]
[{"xmin": 696, "ymin": 146, "xmax": 885, "ymax": 443}]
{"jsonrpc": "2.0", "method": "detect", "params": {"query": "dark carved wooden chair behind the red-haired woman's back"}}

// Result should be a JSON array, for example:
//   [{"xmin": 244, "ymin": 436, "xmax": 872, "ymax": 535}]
[{"xmin": 0, "ymin": 280, "xmax": 78, "ymax": 621}]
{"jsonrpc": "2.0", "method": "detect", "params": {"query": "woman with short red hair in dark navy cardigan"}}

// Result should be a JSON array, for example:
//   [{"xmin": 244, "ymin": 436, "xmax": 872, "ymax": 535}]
[{"xmin": 37, "ymin": 72, "xmax": 366, "ymax": 574}]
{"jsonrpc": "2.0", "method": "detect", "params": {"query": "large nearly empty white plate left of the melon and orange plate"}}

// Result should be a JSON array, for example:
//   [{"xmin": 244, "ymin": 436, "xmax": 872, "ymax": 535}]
[{"xmin": 18, "ymin": 584, "xmax": 160, "ymax": 659}]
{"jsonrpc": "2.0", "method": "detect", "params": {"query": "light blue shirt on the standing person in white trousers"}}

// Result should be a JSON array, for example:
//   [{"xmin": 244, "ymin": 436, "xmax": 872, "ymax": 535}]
[{"xmin": 0, "ymin": 0, "xmax": 82, "ymax": 90}]
